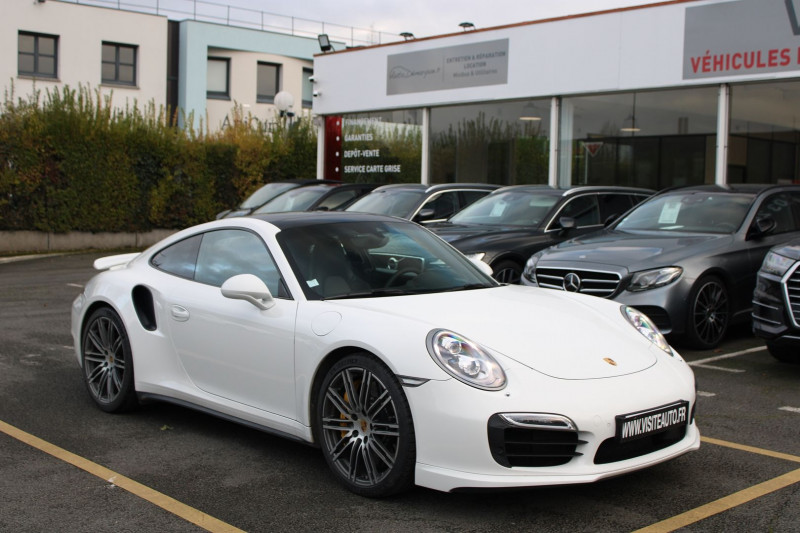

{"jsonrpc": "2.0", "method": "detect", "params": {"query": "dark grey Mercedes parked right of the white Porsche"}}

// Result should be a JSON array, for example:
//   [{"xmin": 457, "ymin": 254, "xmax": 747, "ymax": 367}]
[{"xmin": 522, "ymin": 184, "xmax": 800, "ymax": 349}]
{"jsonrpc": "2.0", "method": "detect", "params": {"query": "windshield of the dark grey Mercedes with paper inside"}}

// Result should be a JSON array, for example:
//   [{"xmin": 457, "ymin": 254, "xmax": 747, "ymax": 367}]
[{"xmin": 615, "ymin": 192, "xmax": 753, "ymax": 233}]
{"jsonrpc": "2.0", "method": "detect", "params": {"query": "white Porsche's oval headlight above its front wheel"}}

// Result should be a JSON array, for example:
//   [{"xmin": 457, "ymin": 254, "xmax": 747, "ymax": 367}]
[{"xmin": 426, "ymin": 329, "xmax": 506, "ymax": 390}]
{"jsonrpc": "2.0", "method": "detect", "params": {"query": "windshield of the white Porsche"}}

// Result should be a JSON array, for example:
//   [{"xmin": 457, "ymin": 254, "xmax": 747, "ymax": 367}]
[{"xmin": 278, "ymin": 221, "xmax": 497, "ymax": 300}]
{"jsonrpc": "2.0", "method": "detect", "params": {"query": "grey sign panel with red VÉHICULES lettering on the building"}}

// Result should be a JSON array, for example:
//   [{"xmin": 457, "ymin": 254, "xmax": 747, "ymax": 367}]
[{"xmin": 683, "ymin": 0, "xmax": 800, "ymax": 79}]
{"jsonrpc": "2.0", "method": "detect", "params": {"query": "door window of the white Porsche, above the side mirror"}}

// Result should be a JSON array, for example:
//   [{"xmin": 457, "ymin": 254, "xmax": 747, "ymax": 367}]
[{"xmin": 194, "ymin": 229, "xmax": 285, "ymax": 296}]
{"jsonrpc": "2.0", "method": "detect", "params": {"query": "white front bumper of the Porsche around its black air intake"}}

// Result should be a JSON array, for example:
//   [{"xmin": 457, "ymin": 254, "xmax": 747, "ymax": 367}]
[{"xmin": 406, "ymin": 356, "xmax": 700, "ymax": 492}]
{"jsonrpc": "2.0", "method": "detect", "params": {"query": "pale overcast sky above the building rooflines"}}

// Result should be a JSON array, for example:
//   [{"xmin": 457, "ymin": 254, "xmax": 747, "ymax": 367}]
[{"xmin": 192, "ymin": 0, "xmax": 657, "ymax": 41}]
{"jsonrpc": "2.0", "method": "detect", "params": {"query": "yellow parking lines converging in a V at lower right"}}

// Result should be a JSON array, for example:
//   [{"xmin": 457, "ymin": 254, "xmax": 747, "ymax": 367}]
[{"xmin": 635, "ymin": 437, "xmax": 800, "ymax": 533}]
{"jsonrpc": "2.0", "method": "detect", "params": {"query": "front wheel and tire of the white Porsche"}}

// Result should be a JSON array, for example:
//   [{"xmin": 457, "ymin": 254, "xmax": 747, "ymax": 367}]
[{"xmin": 315, "ymin": 353, "xmax": 416, "ymax": 498}]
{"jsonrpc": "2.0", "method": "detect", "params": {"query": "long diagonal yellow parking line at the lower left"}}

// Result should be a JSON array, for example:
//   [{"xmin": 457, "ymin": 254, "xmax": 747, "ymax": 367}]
[{"xmin": 0, "ymin": 420, "xmax": 242, "ymax": 533}]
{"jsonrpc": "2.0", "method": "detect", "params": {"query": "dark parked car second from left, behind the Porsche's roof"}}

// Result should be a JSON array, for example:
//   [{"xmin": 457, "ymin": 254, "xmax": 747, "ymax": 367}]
[{"xmin": 253, "ymin": 182, "xmax": 377, "ymax": 215}]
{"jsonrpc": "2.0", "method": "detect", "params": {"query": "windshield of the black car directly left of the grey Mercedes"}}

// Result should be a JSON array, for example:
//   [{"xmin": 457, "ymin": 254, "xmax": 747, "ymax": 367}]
[{"xmin": 448, "ymin": 190, "xmax": 559, "ymax": 226}]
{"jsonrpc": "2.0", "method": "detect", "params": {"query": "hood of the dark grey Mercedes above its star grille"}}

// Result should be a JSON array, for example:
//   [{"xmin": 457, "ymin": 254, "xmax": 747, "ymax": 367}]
[{"xmin": 540, "ymin": 230, "xmax": 733, "ymax": 272}]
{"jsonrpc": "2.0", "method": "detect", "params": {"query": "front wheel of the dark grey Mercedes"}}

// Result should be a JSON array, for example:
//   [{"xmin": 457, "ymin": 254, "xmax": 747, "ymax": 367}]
[{"xmin": 686, "ymin": 276, "xmax": 730, "ymax": 350}]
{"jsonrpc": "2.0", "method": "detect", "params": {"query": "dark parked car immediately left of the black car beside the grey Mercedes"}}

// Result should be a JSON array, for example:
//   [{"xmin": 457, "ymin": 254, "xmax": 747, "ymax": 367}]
[{"xmin": 346, "ymin": 183, "xmax": 500, "ymax": 224}]
